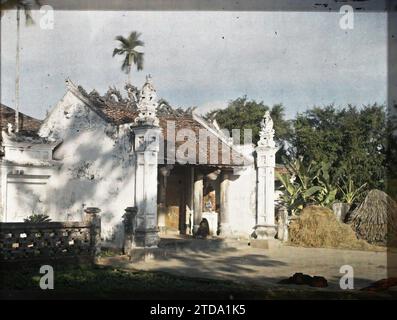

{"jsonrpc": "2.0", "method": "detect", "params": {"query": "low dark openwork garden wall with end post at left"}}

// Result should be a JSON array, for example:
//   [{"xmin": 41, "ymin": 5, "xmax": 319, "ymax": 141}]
[{"xmin": 0, "ymin": 209, "xmax": 101, "ymax": 268}]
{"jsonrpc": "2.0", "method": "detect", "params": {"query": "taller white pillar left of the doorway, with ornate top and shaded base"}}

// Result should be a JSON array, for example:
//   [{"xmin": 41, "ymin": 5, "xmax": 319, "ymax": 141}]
[{"xmin": 132, "ymin": 76, "xmax": 160, "ymax": 247}]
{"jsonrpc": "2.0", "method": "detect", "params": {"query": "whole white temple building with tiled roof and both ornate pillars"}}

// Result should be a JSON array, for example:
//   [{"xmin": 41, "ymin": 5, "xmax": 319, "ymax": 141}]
[{"xmin": 0, "ymin": 76, "xmax": 277, "ymax": 247}]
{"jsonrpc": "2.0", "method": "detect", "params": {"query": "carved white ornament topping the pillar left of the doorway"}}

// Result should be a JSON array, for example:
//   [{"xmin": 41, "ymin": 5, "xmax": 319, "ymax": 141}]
[{"xmin": 135, "ymin": 75, "xmax": 159, "ymax": 126}]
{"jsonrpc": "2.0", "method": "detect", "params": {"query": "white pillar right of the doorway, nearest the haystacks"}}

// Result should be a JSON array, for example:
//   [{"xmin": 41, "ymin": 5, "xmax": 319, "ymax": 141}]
[{"xmin": 255, "ymin": 111, "xmax": 277, "ymax": 239}]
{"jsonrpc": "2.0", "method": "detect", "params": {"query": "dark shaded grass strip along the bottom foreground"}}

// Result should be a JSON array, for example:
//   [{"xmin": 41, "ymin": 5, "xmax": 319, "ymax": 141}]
[{"xmin": 0, "ymin": 266, "xmax": 396, "ymax": 299}]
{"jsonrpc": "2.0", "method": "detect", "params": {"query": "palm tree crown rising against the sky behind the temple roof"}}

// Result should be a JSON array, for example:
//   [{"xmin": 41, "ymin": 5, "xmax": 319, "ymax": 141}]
[{"xmin": 113, "ymin": 31, "xmax": 144, "ymax": 84}]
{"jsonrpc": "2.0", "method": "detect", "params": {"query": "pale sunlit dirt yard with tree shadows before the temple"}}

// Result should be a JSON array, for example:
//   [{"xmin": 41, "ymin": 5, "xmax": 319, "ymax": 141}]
[{"xmin": 100, "ymin": 239, "xmax": 397, "ymax": 290}]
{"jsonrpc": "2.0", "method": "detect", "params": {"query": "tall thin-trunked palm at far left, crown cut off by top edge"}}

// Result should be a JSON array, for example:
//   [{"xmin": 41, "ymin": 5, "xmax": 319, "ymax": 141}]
[{"xmin": 1, "ymin": 0, "xmax": 41, "ymax": 132}]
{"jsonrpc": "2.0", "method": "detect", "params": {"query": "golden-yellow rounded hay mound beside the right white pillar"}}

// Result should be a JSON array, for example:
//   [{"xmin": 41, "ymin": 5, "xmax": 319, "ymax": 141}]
[{"xmin": 289, "ymin": 206, "xmax": 372, "ymax": 250}]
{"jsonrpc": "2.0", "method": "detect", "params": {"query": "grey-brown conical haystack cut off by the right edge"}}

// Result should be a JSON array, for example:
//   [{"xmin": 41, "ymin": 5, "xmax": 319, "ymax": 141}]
[{"xmin": 348, "ymin": 190, "xmax": 397, "ymax": 245}]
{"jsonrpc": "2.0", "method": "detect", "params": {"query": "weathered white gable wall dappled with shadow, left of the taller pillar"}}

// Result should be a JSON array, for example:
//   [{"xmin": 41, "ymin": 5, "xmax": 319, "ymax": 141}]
[{"xmin": 40, "ymin": 92, "xmax": 135, "ymax": 244}]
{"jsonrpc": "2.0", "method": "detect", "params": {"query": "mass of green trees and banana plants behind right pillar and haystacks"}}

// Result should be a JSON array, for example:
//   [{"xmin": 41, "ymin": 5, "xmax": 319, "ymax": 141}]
[{"xmin": 206, "ymin": 96, "xmax": 388, "ymax": 212}]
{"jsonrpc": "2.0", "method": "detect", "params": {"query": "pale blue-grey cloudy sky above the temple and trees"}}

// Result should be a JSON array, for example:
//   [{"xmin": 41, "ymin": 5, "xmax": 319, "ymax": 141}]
[{"xmin": 1, "ymin": 11, "xmax": 387, "ymax": 119}]
